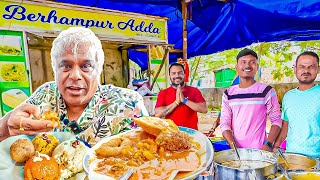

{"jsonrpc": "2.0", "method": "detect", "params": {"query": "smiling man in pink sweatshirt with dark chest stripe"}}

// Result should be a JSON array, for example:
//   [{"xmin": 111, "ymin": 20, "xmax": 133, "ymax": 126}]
[{"xmin": 220, "ymin": 48, "xmax": 282, "ymax": 151}]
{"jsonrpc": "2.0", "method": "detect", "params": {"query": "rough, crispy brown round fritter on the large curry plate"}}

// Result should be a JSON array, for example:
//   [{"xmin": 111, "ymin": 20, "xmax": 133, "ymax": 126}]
[{"xmin": 156, "ymin": 131, "xmax": 192, "ymax": 151}]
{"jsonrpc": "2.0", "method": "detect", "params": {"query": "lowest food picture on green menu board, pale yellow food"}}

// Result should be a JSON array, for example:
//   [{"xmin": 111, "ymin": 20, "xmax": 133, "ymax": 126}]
[{"xmin": 1, "ymin": 89, "xmax": 28, "ymax": 108}]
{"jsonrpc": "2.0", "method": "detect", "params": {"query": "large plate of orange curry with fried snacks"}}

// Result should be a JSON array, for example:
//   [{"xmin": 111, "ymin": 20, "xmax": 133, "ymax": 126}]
[{"xmin": 83, "ymin": 117, "xmax": 213, "ymax": 179}]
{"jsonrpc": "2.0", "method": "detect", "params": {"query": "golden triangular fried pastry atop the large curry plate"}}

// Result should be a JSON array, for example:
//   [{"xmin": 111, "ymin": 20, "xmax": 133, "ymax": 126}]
[{"xmin": 133, "ymin": 116, "xmax": 179, "ymax": 136}]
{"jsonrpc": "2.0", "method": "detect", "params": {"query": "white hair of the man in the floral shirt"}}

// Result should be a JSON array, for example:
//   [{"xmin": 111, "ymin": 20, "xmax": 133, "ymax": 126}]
[{"xmin": 51, "ymin": 27, "xmax": 104, "ymax": 80}]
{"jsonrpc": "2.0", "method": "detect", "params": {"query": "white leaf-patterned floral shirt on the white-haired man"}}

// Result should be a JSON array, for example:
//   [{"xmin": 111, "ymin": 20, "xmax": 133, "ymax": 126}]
[{"xmin": 26, "ymin": 82, "xmax": 148, "ymax": 145}]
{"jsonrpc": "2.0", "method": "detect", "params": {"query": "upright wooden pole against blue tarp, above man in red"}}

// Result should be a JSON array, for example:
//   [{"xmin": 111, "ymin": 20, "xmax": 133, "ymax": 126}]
[{"xmin": 181, "ymin": 0, "xmax": 188, "ymax": 60}]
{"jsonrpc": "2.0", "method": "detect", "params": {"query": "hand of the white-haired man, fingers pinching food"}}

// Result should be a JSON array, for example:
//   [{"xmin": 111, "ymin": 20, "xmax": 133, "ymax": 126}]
[{"xmin": 7, "ymin": 104, "xmax": 58, "ymax": 136}]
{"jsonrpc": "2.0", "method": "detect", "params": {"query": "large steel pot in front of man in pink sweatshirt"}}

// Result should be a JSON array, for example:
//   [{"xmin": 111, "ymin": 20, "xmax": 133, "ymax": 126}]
[{"xmin": 214, "ymin": 148, "xmax": 278, "ymax": 180}]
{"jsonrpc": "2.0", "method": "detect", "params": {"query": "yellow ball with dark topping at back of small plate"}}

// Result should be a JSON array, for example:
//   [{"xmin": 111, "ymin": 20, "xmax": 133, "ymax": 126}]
[{"xmin": 32, "ymin": 133, "xmax": 60, "ymax": 156}]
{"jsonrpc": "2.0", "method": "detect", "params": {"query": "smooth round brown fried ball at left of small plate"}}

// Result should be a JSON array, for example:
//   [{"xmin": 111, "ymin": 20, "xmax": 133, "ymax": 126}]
[{"xmin": 10, "ymin": 138, "xmax": 34, "ymax": 163}]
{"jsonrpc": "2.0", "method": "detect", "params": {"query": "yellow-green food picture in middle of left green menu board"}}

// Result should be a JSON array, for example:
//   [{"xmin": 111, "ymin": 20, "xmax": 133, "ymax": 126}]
[{"xmin": 1, "ymin": 63, "xmax": 26, "ymax": 81}]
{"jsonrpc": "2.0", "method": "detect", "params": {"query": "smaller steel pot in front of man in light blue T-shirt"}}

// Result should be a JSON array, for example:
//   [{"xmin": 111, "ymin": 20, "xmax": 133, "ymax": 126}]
[{"xmin": 278, "ymin": 153, "xmax": 317, "ymax": 171}]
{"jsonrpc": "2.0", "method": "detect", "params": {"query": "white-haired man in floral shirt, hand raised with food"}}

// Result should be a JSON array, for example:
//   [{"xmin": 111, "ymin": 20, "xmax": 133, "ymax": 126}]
[{"xmin": 0, "ymin": 27, "xmax": 148, "ymax": 144}]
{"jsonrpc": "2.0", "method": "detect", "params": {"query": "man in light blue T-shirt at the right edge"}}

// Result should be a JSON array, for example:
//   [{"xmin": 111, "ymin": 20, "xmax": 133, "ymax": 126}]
[{"xmin": 274, "ymin": 51, "xmax": 320, "ymax": 158}]
